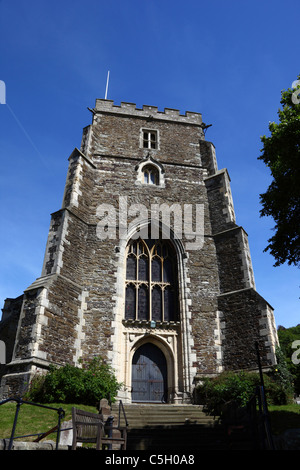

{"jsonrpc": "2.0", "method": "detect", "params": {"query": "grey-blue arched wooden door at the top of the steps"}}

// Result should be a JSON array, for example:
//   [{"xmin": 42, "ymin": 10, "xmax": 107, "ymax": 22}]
[{"xmin": 131, "ymin": 343, "xmax": 168, "ymax": 403}]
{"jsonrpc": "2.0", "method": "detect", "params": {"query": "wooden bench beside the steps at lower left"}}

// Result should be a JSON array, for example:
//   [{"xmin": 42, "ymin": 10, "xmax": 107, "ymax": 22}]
[{"xmin": 72, "ymin": 407, "xmax": 127, "ymax": 450}]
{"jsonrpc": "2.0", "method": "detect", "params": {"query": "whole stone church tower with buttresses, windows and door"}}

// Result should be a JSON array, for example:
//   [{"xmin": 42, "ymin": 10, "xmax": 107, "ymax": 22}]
[{"xmin": 0, "ymin": 99, "xmax": 277, "ymax": 403}]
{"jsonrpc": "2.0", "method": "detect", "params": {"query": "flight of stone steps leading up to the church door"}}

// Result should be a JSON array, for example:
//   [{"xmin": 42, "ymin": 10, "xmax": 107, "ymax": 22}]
[{"xmin": 108, "ymin": 403, "xmax": 253, "ymax": 453}]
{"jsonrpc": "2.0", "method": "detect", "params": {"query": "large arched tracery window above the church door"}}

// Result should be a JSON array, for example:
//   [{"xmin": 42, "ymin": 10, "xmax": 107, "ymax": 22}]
[{"xmin": 125, "ymin": 239, "xmax": 178, "ymax": 322}]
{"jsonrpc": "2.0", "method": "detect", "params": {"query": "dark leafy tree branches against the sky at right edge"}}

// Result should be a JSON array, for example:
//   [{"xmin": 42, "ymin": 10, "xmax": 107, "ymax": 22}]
[{"xmin": 258, "ymin": 75, "xmax": 300, "ymax": 266}]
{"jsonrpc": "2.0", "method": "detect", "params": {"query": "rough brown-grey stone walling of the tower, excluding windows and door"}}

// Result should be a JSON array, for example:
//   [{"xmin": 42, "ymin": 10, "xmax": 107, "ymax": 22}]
[{"xmin": 0, "ymin": 100, "xmax": 276, "ymax": 397}]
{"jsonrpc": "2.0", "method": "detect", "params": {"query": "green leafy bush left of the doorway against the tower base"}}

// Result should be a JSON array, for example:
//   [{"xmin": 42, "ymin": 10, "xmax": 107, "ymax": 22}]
[{"xmin": 25, "ymin": 357, "xmax": 121, "ymax": 406}]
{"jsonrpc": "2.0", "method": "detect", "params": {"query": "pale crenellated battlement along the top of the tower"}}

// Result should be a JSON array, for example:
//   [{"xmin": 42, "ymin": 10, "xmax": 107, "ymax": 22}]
[{"xmin": 94, "ymin": 99, "xmax": 202, "ymax": 125}]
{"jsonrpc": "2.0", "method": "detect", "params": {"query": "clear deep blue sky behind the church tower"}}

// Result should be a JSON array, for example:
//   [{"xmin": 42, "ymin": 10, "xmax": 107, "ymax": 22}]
[{"xmin": 0, "ymin": 0, "xmax": 300, "ymax": 327}]
